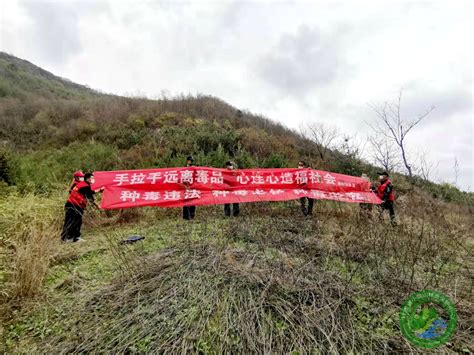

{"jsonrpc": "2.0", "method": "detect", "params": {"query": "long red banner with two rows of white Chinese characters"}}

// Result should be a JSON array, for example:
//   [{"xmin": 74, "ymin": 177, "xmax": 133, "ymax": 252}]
[{"xmin": 92, "ymin": 166, "xmax": 381, "ymax": 209}]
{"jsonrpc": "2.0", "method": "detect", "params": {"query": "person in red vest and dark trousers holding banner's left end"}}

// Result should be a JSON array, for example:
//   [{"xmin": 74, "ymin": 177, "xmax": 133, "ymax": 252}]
[{"xmin": 61, "ymin": 173, "xmax": 102, "ymax": 242}]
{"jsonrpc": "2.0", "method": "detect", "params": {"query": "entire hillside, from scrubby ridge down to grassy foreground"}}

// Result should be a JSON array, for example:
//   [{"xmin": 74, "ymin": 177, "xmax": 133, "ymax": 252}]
[{"xmin": 0, "ymin": 53, "xmax": 474, "ymax": 353}]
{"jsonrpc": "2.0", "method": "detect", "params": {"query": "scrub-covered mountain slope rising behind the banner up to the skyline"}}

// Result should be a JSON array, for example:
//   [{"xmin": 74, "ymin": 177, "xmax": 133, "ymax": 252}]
[{"xmin": 0, "ymin": 52, "xmax": 466, "ymax": 206}]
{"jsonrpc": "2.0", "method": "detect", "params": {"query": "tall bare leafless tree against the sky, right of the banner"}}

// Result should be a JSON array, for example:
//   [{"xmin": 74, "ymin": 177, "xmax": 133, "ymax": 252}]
[{"xmin": 369, "ymin": 90, "xmax": 434, "ymax": 178}]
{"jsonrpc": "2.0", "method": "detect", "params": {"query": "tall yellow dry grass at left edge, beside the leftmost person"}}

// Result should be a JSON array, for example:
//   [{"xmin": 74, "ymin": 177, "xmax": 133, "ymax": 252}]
[{"xmin": 0, "ymin": 195, "xmax": 63, "ymax": 301}]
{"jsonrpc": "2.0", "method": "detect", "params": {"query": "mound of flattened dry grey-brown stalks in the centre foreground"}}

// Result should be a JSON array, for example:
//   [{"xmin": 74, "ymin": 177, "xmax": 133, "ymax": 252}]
[{"xmin": 44, "ymin": 239, "xmax": 374, "ymax": 353}]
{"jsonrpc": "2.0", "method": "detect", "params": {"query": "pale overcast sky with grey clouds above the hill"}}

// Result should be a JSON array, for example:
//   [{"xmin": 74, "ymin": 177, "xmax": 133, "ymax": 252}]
[{"xmin": 0, "ymin": 0, "xmax": 474, "ymax": 191}]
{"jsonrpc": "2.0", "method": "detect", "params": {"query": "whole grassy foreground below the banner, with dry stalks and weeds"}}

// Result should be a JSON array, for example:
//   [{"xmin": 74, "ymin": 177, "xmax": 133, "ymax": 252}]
[{"xmin": 0, "ymin": 194, "xmax": 474, "ymax": 354}]
